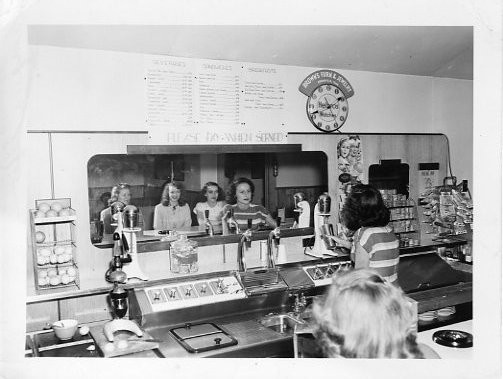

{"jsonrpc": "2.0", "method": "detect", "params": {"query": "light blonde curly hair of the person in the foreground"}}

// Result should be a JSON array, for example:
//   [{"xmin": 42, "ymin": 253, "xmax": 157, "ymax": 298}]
[{"xmin": 313, "ymin": 269, "xmax": 424, "ymax": 358}]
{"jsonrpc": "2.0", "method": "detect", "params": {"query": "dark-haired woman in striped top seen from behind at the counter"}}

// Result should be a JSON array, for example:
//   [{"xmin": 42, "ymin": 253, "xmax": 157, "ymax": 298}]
[{"xmin": 329, "ymin": 184, "xmax": 400, "ymax": 284}]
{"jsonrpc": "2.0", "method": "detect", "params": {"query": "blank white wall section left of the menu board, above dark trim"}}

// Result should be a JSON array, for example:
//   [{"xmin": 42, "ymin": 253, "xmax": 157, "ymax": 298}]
[{"xmin": 26, "ymin": 46, "xmax": 145, "ymax": 131}]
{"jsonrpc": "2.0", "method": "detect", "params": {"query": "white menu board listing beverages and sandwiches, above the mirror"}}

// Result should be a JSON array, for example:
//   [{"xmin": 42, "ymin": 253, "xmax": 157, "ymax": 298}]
[{"xmin": 145, "ymin": 56, "xmax": 286, "ymax": 142}]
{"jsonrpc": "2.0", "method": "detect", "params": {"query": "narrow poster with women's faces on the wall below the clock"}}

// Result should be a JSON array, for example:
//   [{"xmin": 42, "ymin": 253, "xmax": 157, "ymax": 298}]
[{"xmin": 337, "ymin": 135, "xmax": 363, "ymax": 236}]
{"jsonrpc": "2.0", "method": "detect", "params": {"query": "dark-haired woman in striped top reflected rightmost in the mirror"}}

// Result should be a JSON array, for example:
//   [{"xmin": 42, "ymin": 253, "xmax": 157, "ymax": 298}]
[{"xmin": 222, "ymin": 178, "xmax": 277, "ymax": 232}]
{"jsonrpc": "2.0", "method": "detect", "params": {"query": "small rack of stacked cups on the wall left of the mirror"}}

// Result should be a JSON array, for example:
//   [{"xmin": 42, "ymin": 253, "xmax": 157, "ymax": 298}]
[{"xmin": 30, "ymin": 198, "xmax": 80, "ymax": 294}]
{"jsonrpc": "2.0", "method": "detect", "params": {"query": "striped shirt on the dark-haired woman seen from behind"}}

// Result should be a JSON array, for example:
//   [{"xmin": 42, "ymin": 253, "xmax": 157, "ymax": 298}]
[{"xmin": 354, "ymin": 226, "xmax": 400, "ymax": 283}]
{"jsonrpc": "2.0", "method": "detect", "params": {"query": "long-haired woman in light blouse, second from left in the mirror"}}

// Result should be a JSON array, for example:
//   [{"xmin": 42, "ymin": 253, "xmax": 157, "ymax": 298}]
[{"xmin": 154, "ymin": 182, "xmax": 192, "ymax": 230}]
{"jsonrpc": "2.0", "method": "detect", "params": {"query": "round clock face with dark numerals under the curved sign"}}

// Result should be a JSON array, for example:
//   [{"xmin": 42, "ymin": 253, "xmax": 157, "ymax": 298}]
[{"xmin": 306, "ymin": 84, "xmax": 349, "ymax": 132}]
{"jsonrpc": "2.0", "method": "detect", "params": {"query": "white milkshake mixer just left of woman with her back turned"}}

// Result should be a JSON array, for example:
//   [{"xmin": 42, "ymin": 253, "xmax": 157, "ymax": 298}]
[{"xmin": 306, "ymin": 192, "xmax": 337, "ymax": 258}]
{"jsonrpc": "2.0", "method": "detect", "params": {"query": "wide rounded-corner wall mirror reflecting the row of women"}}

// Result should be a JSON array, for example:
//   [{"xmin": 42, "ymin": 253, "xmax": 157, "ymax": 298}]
[{"xmin": 87, "ymin": 151, "xmax": 328, "ymax": 247}]
